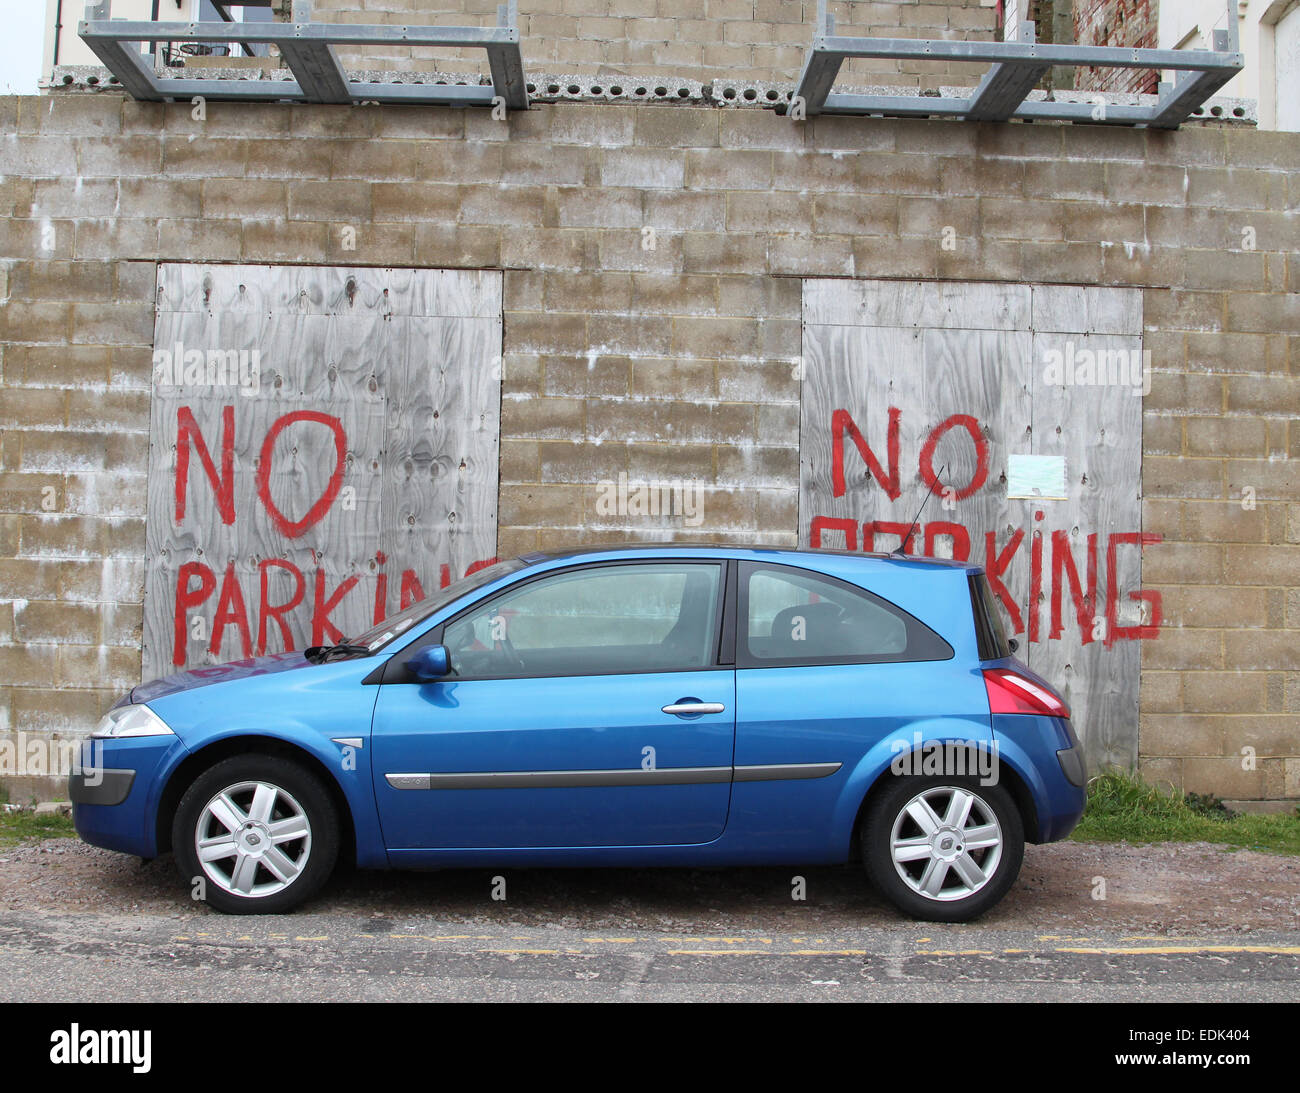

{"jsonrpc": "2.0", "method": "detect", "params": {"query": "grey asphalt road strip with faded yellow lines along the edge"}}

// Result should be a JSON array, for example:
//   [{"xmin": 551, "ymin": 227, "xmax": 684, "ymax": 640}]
[{"xmin": 0, "ymin": 912, "xmax": 1300, "ymax": 1002}]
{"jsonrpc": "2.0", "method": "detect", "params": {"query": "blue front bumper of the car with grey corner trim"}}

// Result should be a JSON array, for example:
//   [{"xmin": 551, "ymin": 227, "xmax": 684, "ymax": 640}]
[{"xmin": 68, "ymin": 736, "xmax": 189, "ymax": 858}]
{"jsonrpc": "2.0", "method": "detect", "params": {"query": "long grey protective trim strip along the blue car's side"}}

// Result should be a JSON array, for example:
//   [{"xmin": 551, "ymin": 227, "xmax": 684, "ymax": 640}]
[{"xmin": 384, "ymin": 763, "xmax": 840, "ymax": 789}]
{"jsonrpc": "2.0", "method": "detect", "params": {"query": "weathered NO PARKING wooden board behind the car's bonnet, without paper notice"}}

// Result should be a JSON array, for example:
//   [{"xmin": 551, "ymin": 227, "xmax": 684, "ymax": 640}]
[{"xmin": 143, "ymin": 264, "xmax": 502, "ymax": 678}]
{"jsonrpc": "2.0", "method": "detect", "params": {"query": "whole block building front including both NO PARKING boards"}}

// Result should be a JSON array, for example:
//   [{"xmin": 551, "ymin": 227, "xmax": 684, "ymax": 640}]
[{"xmin": 0, "ymin": 0, "xmax": 1300, "ymax": 802}]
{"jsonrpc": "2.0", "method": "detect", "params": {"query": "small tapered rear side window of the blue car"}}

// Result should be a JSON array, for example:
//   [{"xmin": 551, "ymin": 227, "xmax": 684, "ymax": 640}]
[{"xmin": 740, "ymin": 567, "xmax": 953, "ymax": 667}]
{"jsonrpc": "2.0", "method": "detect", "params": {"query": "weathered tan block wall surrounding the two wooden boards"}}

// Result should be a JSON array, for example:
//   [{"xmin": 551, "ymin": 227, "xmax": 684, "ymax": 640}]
[{"xmin": 0, "ymin": 94, "xmax": 1300, "ymax": 798}]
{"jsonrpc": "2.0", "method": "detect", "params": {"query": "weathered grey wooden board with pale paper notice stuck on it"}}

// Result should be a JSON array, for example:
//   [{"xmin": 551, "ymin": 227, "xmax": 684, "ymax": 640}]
[{"xmin": 800, "ymin": 281, "xmax": 1152, "ymax": 767}]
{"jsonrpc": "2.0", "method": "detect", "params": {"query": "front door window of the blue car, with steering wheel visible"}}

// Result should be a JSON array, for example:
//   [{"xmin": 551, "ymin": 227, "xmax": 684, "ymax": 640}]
[{"xmin": 442, "ymin": 563, "xmax": 722, "ymax": 678}]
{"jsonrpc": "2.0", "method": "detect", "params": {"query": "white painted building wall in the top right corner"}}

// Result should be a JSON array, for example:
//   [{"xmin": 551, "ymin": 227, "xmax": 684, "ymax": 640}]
[{"xmin": 1158, "ymin": 0, "xmax": 1300, "ymax": 131}]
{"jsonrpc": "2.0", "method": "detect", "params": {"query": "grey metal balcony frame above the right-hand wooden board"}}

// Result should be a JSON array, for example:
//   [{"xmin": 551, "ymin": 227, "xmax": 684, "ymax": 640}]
[{"xmin": 788, "ymin": 0, "xmax": 1244, "ymax": 129}]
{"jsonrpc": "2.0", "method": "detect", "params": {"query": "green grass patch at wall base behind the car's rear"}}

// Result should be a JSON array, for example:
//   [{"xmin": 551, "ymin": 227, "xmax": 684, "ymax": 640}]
[{"xmin": 1070, "ymin": 771, "xmax": 1300, "ymax": 854}]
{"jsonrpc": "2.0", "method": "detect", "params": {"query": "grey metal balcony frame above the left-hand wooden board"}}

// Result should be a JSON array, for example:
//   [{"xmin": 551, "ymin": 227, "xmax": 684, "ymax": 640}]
[{"xmin": 78, "ymin": 0, "xmax": 528, "ymax": 110}]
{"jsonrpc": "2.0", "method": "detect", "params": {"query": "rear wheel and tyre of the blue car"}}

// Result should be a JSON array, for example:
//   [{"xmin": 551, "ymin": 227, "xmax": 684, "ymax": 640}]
[{"xmin": 861, "ymin": 776, "xmax": 1024, "ymax": 923}]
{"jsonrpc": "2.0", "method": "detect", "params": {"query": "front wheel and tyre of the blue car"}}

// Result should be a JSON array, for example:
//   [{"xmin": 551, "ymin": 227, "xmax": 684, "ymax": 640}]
[{"xmin": 172, "ymin": 755, "xmax": 339, "ymax": 915}]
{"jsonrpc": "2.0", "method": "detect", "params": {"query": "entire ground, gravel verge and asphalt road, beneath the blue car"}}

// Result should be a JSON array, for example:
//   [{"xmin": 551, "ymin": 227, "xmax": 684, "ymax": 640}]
[{"xmin": 0, "ymin": 840, "xmax": 1300, "ymax": 1002}]
